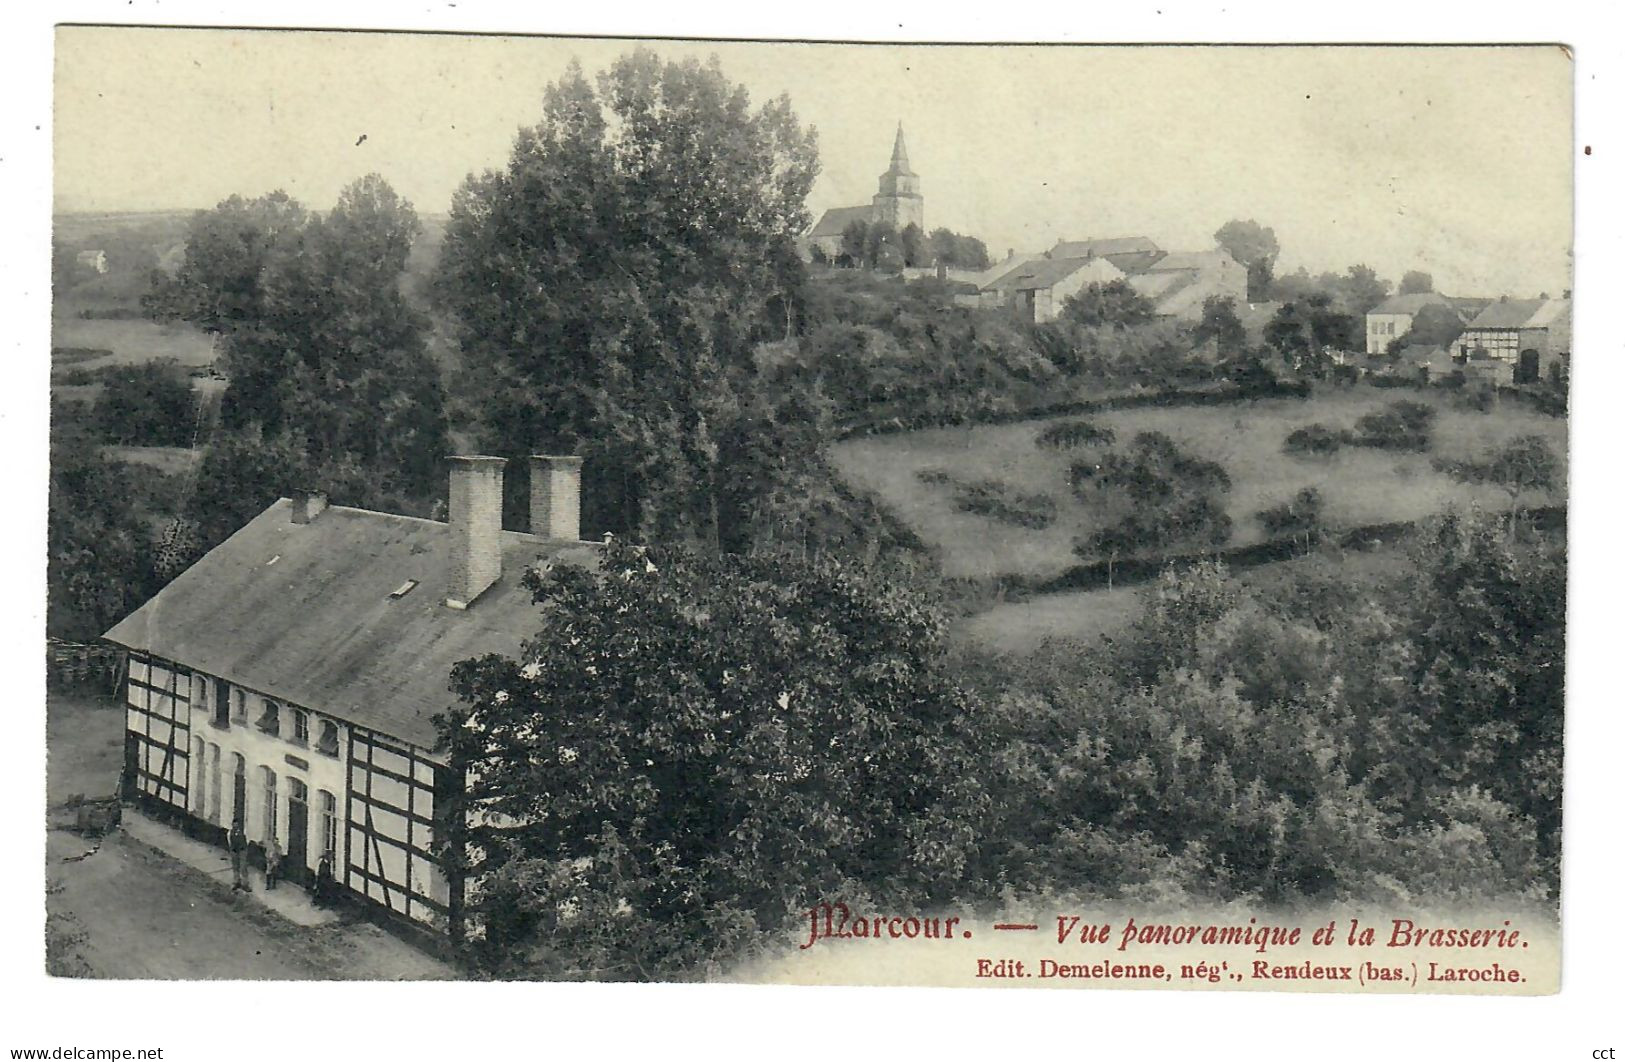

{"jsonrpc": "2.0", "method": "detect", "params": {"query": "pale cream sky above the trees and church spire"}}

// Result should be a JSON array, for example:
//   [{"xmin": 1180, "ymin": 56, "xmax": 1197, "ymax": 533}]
[{"xmin": 54, "ymin": 28, "xmax": 1575, "ymax": 296}]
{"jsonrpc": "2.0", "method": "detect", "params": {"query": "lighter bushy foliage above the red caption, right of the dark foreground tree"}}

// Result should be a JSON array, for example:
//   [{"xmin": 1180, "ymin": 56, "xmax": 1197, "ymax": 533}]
[{"xmin": 962, "ymin": 516, "xmax": 1563, "ymax": 903}]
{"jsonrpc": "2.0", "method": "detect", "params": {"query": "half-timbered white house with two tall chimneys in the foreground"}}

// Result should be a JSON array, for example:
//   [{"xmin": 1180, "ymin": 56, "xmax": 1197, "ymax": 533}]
[{"xmin": 106, "ymin": 456, "xmax": 596, "ymax": 934}]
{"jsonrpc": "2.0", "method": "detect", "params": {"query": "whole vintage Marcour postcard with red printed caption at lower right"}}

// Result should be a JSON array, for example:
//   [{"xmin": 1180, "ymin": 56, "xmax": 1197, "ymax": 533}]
[{"xmin": 46, "ymin": 26, "xmax": 1566, "ymax": 995}]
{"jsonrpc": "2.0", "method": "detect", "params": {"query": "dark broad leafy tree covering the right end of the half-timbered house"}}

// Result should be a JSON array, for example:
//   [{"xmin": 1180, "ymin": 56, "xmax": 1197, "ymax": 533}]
[{"xmin": 437, "ymin": 541, "xmax": 982, "ymax": 979}]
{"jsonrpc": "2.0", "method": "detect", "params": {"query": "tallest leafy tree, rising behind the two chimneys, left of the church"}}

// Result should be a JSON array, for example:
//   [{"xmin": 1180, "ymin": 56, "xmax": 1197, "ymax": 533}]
[{"xmin": 437, "ymin": 49, "xmax": 817, "ymax": 547}]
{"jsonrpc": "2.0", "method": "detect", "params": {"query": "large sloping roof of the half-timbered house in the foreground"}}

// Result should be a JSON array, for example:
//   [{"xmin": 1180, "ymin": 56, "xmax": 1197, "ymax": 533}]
[{"xmin": 106, "ymin": 499, "xmax": 598, "ymax": 749}]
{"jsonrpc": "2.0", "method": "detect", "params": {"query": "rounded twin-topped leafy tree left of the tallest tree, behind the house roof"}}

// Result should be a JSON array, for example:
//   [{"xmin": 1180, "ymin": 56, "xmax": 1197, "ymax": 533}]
[{"xmin": 148, "ymin": 174, "xmax": 449, "ymax": 495}]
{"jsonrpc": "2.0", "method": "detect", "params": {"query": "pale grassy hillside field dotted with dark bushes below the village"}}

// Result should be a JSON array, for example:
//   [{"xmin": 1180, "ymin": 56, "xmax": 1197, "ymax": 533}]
[{"xmin": 832, "ymin": 386, "xmax": 1568, "ymax": 578}]
